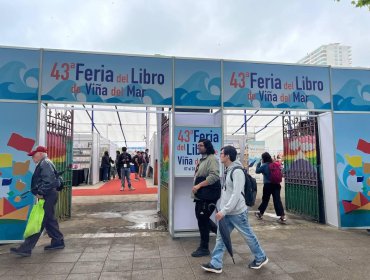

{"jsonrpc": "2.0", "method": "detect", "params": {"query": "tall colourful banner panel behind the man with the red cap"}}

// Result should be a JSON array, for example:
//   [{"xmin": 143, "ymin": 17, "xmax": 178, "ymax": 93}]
[{"xmin": 0, "ymin": 103, "xmax": 37, "ymax": 243}]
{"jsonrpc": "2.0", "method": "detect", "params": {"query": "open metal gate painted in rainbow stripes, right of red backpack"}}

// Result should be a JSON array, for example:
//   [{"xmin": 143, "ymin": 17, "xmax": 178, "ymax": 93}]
[{"xmin": 283, "ymin": 116, "xmax": 324, "ymax": 222}]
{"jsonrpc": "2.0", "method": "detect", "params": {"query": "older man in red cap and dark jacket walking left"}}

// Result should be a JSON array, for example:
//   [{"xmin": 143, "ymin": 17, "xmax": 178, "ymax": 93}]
[{"xmin": 10, "ymin": 146, "xmax": 64, "ymax": 257}]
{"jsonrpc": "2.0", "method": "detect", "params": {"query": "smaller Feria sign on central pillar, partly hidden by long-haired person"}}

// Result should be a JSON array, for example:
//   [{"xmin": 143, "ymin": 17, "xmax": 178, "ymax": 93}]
[{"xmin": 174, "ymin": 126, "xmax": 222, "ymax": 176}]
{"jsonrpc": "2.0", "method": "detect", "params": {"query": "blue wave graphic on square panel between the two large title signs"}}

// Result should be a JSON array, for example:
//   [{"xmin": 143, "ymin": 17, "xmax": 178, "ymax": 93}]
[{"xmin": 175, "ymin": 71, "xmax": 221, "ymax": 107}]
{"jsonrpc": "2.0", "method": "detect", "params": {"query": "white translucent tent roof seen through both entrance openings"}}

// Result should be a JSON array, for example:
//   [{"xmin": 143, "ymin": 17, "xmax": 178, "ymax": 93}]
[{"xmin": 50, "ymin": 104, "xmax": 306, "ymax": 147}]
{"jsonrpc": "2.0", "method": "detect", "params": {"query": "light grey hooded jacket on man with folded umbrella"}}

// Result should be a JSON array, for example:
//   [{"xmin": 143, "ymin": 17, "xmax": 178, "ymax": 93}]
[{"xmin": 220, "ymin": 160, "xmax": 247, "ymax": 216}]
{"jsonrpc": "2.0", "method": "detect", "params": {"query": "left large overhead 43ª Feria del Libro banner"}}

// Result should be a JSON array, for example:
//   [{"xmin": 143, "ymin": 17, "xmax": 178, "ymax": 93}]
[{"xmin": 41, "ymin": 51, "xmax": 172, "ymax": 106}]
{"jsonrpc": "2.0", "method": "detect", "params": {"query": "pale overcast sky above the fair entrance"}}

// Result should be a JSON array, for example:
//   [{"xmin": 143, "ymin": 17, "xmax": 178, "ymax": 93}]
[{"xmin": 0, "ymin": 0, "xmax": 370, "ymax": 67}]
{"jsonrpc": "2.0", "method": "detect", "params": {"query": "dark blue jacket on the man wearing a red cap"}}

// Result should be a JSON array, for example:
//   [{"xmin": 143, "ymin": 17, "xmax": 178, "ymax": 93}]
[{"xmin": 31, "ymin": 158, "xmax": 58, "ymax": 196}]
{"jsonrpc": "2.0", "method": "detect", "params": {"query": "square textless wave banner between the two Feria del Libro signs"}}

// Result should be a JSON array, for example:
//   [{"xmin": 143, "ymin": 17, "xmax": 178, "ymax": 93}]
[{"xmin": 175, "ymin": 59, "xmax": 221, "ymax": 107}]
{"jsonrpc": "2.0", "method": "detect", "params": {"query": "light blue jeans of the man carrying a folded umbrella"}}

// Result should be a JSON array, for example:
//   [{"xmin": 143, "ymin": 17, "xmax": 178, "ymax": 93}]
[{"xmin": 211, "ymin": 211, "xmax": 266, "ymax": 268}]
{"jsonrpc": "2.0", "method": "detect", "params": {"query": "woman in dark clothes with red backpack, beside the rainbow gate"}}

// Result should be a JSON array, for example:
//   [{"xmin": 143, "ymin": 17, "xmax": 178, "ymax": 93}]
[{"xmin": 255, "ymin": 152, "xmax": 287, "ymax": 223}]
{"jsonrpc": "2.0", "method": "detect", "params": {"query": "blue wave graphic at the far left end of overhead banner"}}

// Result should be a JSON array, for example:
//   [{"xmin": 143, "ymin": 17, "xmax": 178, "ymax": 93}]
[{"xmin": 0, "ymin": 61, "xmax": 39, "ymax": 100}]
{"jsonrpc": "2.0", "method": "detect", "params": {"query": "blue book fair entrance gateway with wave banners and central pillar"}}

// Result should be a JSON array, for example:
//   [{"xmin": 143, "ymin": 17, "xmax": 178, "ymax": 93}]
[{"xmin": 0, "ymin": 47, "xmax": 370, "ymax": 242}]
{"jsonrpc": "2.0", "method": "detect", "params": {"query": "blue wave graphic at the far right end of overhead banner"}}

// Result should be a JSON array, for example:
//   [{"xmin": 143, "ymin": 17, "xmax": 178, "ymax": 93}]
[{"xmin": 333, "ymin": 79, "xmax": 370, "ymax": 111}]
